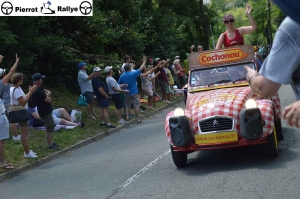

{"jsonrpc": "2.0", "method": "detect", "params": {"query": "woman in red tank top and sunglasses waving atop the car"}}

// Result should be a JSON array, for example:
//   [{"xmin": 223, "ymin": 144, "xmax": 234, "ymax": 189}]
[{"xmin": 216, "ymin": 4, "xmax": 257, "ymax": 49}]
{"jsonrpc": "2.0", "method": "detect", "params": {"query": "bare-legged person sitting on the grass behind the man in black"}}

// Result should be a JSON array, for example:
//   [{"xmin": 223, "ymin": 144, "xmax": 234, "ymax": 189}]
[{"xmin": 27, "ymin": 107, "xmax": 85, "ymax": 127}]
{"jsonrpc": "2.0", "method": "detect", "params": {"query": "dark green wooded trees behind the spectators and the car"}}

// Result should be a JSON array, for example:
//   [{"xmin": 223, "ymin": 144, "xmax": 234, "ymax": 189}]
[{"xmin": 0, "ymin": 0, "xmax": 285, "ymax": 93}]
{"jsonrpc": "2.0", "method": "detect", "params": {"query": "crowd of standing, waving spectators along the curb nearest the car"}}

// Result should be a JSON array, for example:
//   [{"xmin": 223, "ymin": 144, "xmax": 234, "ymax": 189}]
[{"xmin": 78, "ymin": 55, "xmax": 186, "ymax": 128}]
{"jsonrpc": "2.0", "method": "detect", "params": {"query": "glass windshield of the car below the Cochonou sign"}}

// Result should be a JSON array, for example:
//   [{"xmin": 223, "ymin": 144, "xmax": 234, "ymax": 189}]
[{"xmin": 189, "ymin": 62, "xmax": 255, "ymax": 87}]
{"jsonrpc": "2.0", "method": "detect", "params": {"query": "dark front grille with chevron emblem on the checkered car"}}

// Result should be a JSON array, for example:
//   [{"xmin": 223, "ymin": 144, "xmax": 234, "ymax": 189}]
[{"xmin": 199, "ymin": 117, "xmax": 233, "ymax": 133}]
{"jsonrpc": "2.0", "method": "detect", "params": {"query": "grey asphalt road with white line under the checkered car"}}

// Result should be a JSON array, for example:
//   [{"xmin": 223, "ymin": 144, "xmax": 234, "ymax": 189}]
[{"xmin": 0, "ymin": 86, "xmax": 300, "ymax": 199}]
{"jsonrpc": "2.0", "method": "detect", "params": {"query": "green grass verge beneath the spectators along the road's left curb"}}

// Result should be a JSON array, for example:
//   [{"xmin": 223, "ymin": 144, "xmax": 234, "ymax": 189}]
[{"xmin": 0, "ymin": 87, "xmax": 182, "ymax": 174}]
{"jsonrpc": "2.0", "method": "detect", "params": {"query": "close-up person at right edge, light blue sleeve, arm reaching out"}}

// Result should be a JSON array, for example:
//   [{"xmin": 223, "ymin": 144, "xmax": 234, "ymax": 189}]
[{"xmin": 245, "ymin": 16, "xmax": 300, "ymax": 131}]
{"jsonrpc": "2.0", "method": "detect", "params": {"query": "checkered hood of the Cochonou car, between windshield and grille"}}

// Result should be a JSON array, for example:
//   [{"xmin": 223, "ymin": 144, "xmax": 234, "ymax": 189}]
[{"xmin": 186, "ymin": 87, "xmax": 253, "ymax": 119}]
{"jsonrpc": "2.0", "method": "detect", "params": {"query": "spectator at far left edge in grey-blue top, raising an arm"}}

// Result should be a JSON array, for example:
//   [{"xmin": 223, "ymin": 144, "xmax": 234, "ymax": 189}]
[{"xmin": 0, "ymin": 54, "xmax": 21, "ymax": 141}]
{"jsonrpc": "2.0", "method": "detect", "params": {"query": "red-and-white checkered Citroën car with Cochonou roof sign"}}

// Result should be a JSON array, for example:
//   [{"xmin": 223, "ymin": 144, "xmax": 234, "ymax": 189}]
[{"xmin": 165, "ymin": 45, "xmax": 283, "ymax": 167}]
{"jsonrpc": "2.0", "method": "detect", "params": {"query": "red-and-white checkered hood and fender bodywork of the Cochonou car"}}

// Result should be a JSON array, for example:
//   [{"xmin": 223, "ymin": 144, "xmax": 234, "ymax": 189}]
[{"xmin": 165, "ymin": 86, "xmax": 280, "ymax": 144}]
